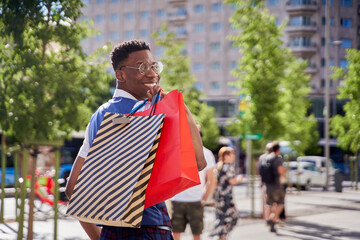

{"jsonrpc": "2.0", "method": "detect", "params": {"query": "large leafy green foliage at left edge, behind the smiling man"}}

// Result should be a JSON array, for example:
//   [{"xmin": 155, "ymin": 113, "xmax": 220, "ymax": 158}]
[{"xmin": 0, "ymin": 0, "xmax": 112, "ymax": 141}]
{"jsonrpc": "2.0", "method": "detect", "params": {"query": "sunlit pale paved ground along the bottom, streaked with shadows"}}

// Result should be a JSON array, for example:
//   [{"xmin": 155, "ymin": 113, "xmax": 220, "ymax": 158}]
[{"xmin": 0, "ymin": 182, "xmax": 360, "ymax": 240}]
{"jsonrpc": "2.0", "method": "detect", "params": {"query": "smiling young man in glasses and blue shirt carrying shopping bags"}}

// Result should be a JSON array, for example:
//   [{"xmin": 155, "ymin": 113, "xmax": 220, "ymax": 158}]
[{"xmin": 66, "ymin": 40, "xmax": 206, "ymax": 240}]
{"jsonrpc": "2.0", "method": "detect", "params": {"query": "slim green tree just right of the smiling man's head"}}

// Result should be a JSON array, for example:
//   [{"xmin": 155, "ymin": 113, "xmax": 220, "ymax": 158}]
[{"xmin": 153, "ymin": 24, "xmax": 219, "ymax": 149}]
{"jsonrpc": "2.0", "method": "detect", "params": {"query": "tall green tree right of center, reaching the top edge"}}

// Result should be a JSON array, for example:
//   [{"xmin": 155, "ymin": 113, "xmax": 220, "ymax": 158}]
[{"xmin": 225, "ymin": 0, "xmax": 286, "ymax": 140}]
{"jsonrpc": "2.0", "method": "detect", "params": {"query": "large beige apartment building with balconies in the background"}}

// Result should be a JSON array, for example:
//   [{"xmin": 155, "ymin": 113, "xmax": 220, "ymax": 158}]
[{"xmin": 83, "ymin": 0, "xmax": 360, "ymax": 132}]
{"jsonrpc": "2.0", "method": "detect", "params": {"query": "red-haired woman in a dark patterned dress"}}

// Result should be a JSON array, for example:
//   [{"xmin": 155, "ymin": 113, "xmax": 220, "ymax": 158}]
[{"xmin": 211, "ymin": 147, "xmax": 243, "ymax": 240}]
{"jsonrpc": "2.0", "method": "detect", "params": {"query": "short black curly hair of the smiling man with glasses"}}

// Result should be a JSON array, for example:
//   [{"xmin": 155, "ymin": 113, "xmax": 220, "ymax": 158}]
[{"xmin": 110, "ymin": 39, "xmax": 150, "ymax": 71}]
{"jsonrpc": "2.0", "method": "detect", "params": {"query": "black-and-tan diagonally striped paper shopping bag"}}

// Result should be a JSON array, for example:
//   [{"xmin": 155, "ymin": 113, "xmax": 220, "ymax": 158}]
[{"xmin": 67, "ymin": 113, "xmax": 165, "ymax": 227}]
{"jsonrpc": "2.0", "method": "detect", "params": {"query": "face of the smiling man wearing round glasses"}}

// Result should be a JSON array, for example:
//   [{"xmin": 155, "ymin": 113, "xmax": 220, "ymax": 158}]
[{"xmin": 116, "ymin": 50, "xmax": 160, "ymax": 100}]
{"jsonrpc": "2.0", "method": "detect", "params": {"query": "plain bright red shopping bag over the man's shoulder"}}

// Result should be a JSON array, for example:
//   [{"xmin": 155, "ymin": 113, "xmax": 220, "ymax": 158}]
[{"xmin": 134, "ymin": 90, "xmax": 200, "ymax": 208}]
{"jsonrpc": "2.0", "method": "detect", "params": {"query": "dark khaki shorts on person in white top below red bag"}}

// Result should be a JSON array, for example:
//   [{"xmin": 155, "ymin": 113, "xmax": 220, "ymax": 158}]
[{"xmin": 171, "ymin": 201, "xmax": 204, "ymax": 235}]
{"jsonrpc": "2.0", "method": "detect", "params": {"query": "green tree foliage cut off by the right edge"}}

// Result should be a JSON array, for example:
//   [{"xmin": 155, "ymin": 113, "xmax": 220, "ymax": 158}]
[{"xmin": 330, "ymin": 49, "xmax": 360, "ymax": 154}]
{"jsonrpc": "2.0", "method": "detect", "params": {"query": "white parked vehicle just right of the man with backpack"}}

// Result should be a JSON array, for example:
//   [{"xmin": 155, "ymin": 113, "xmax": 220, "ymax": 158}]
[{"xmin": 287, "ymin": 161, "xmax": 326, "ymax": 190}]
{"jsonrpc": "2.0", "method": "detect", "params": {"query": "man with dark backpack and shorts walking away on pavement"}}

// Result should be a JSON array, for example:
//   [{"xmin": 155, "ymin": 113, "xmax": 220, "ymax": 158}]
[{"xmin": 259, "ymin": 142, "xmax": 286, "ymax": 232}]
